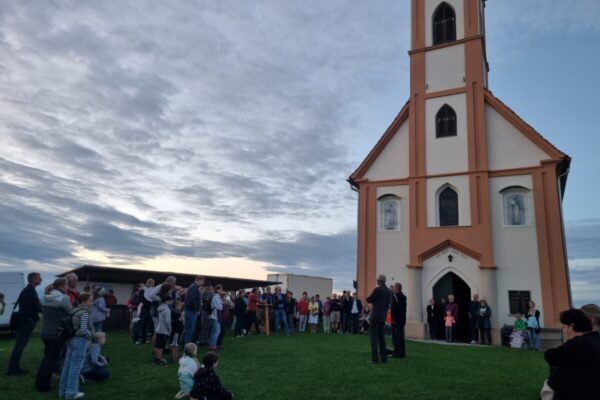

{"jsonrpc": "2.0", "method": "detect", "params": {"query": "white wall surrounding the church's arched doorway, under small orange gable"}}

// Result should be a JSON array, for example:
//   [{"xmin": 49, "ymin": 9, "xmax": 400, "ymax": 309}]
[{"xmin": 421, "ymin": 248, "xmax": 480, "ymax": 321}]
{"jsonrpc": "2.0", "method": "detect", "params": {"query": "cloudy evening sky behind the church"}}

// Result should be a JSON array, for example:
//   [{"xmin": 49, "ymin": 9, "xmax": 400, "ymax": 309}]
[{"xmin": 0, "ymin": 0, "xmax": 600, "ymax": 301}]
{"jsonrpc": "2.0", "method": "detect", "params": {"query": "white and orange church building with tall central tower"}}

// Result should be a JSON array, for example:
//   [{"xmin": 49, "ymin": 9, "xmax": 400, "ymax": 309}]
[{"xmin": 349, "ymin": 0, "xmax": 571, "ymax": 340}]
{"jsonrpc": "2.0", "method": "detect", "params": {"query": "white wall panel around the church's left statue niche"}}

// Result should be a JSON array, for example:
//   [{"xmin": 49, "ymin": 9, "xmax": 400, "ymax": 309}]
[{"xmin": 376, "ymin": 186, "xmax": 410, "ymax": 284}]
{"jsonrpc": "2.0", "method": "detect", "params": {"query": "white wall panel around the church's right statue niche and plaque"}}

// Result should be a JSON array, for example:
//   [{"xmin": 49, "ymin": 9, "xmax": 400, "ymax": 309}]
[{"xmin": 490, "ymin": 175, "xmax": 543, "ymax": 325}]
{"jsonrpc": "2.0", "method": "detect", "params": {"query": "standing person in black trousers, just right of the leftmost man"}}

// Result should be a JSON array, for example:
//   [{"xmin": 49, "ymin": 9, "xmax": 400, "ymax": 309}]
[{"xmin": 35, "ymin": 278, "xmax": 73, "ymax": 392}]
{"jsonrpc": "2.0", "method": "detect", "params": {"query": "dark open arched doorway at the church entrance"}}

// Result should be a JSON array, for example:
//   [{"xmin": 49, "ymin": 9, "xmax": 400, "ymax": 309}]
[{"xmin": 433, "ymin": 272, "xmax": 471, "ymax": 342}]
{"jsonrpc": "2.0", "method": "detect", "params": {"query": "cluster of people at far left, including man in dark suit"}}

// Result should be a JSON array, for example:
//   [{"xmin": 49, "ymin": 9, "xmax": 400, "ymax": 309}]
[{"xmin": 7, "ymin": 272, "xmax": 109, "ymax": 399}]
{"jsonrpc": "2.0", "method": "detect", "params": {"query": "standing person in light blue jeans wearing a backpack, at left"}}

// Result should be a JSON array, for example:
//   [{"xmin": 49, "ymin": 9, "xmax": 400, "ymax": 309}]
[{"xmin": 58, "ymin": 293, "xmax": 94, "ymax": 399}]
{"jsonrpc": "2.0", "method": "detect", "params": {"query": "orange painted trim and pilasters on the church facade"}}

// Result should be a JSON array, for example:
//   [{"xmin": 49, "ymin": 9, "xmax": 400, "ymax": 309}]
[{"xmin": 349, "ymin": 0, "xmax": 570, "ymax": 327}]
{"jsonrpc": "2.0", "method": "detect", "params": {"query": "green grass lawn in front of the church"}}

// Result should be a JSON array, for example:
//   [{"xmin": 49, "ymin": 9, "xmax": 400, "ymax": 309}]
[{"xmin": 0, "ymin": 332, "xmax": 547, "ymax": 400}]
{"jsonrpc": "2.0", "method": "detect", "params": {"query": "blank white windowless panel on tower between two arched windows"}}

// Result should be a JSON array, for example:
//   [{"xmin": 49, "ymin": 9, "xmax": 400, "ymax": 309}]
[{"xmin": 425, "ymin": 44, "xmax": 465, "ymax": 93}]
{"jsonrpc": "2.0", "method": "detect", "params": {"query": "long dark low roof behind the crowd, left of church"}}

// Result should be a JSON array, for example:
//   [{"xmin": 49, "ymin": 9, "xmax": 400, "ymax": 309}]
[{"xmin": 56, "ymin": 265, "xmax": 281, "ymax": 291}]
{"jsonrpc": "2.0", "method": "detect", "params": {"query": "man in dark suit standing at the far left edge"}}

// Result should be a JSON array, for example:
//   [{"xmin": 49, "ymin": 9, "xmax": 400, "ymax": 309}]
[{"xmin": 7, "ymin": 272, "xmax": 42, "ymax": 375}]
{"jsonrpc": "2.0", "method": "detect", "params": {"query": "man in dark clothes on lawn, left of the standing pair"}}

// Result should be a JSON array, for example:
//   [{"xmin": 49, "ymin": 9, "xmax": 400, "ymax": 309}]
[{"xmin": 367, "ymin": 275, "xmax": 392, "ymax": 364}]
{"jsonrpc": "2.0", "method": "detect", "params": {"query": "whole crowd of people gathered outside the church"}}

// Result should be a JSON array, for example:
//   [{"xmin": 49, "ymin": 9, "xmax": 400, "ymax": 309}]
[{"xmin": 5, "ymin": 273, "xmax": 600, "ymax": 400}]
